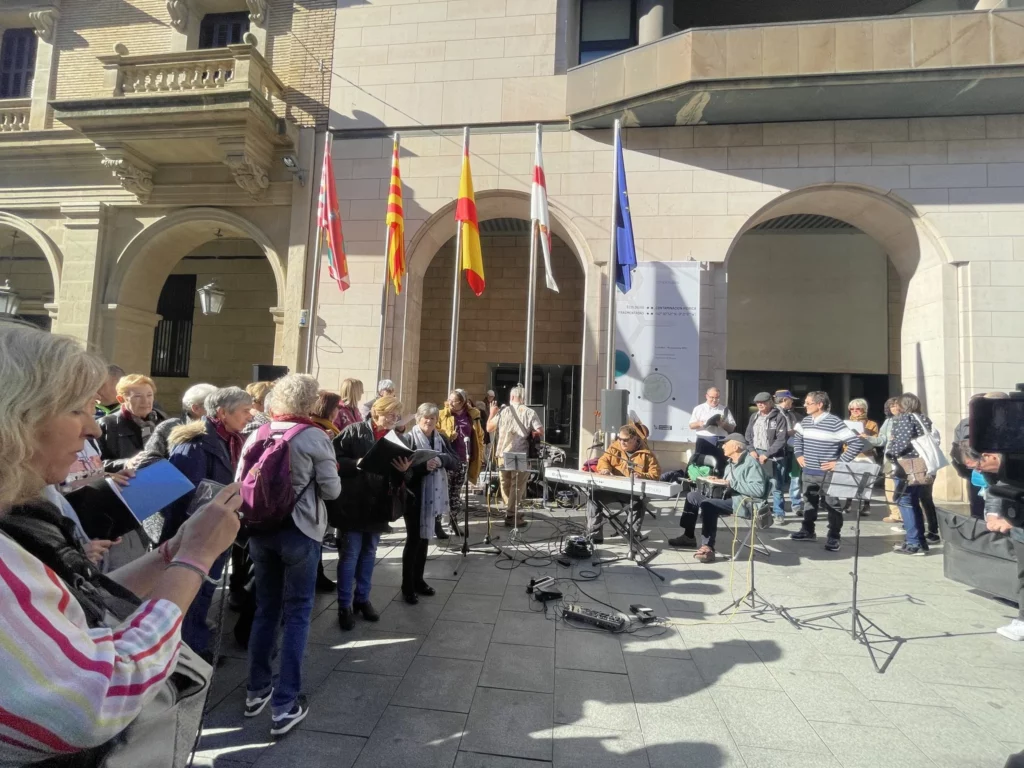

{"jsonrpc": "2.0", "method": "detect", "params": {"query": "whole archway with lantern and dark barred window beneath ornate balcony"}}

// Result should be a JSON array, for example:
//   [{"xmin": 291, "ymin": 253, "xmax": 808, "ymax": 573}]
[{"xmin": 102, "ymin": 208, "xmax": 286, "ymax": 410}]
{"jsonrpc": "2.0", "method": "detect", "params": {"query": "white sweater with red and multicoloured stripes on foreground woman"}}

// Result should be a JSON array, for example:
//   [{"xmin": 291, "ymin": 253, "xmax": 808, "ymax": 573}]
[{"xmin": 0, "ymin": 534, "xmax": 181, "ymax": 766}]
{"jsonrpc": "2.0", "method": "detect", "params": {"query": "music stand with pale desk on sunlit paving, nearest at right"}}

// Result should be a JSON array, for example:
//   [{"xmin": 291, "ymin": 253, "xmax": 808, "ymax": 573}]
[{"xmin": 799, "ymin": 462, "xmax": 903, "ymax": 675}]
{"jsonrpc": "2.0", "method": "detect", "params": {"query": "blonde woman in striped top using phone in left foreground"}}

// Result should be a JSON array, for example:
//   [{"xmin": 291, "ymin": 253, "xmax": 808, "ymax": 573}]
[{"xmin": 0, "ymin": 321, "xmax": 241, "ymax": 765}]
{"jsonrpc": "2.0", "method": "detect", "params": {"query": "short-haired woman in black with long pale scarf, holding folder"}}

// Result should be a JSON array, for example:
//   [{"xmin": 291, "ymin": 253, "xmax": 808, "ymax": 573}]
[{"xmin": 401, "ymin": 402, "xmax": 460, "ymax": 603}]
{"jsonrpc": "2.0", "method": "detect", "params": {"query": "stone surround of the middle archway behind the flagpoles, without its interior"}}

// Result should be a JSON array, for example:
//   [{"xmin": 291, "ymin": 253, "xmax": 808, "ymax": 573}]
[{"xmin": 391, "ymin": 189, "xmax": 602, "ymax": 456}]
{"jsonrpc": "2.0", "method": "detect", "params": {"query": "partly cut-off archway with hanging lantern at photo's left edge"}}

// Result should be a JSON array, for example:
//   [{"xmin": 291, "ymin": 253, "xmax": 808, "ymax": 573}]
[{"xmin": 0, "ymin": 212, "xmax": 60, "ymax": 331}]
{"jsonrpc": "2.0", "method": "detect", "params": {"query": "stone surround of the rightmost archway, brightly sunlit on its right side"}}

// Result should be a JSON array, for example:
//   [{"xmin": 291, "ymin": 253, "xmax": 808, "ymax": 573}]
[{"xmin": 714, "ymin": 183, "xmax": 962, "ymax": 498}]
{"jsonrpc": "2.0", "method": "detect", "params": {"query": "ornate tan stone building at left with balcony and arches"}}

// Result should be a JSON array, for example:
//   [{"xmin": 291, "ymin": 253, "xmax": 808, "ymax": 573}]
[{"xmin": 0, "ymin": 0, "xmax": 335, "ymax": 410}]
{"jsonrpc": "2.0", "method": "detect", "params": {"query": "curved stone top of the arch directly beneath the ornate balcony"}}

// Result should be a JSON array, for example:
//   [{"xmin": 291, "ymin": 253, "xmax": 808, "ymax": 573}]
[{"xmin": 104, "ymin": 208, "xmax": 286, "ymax": 312}]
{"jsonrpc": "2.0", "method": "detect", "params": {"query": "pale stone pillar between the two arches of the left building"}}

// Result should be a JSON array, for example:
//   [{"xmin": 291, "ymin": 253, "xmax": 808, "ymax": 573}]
[{"xmin": 53, "ymin": 203, "xmax": 108, "ymax": 345}]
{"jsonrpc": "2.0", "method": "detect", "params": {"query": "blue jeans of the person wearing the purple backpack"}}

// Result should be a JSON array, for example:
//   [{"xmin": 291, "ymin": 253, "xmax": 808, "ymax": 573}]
[{"xmin": 247, "ymin": 527, "xmax": 321, "ymax": 715}]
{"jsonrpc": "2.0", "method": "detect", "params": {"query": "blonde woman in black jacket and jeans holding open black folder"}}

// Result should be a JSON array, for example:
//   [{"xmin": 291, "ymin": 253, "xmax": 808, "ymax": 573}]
[{"xmin": 328, "ymin": 395, "xmax": 412, "ymax": 632}]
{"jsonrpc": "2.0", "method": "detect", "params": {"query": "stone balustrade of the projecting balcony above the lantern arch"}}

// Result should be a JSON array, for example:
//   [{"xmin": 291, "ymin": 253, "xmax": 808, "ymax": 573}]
[{"xmin": 99, "ymin": 44, "xmax": 284, "ymax": 103}]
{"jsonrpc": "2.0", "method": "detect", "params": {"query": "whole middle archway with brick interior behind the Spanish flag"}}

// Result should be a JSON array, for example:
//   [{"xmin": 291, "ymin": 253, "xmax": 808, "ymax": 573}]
[{"xmin": 393, "ymin": 190, "xmax": 602, "ymax": 462}]
